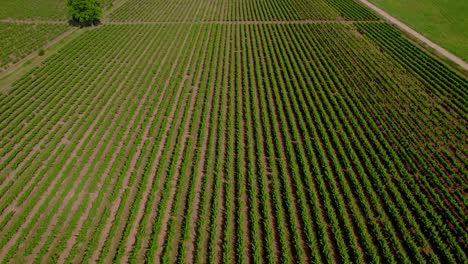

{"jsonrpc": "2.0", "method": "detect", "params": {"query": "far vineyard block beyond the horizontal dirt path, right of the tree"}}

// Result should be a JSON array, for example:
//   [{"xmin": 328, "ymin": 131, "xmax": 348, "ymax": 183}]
[{"xmin": 110, "ymin": 0, "xmax": 378, "ymax": 22}]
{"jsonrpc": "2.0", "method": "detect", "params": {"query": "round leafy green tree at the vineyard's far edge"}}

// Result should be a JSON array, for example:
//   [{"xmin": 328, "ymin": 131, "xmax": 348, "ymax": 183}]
[{"xmin": 67, "ymin": 0, "xmax": 102, "ymax": 25}]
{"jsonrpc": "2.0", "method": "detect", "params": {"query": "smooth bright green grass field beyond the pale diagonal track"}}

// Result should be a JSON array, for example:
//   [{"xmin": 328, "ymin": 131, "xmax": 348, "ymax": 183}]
[{"xmin": 370, "ymin": 0, "xmax": 468, "ymax": 61}]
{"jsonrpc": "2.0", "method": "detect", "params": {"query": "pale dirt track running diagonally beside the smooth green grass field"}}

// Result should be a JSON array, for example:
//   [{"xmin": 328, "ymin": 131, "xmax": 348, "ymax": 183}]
[{"xmin": 359, "ymin": 0, "xmax": 468, "ymax": 70}]
